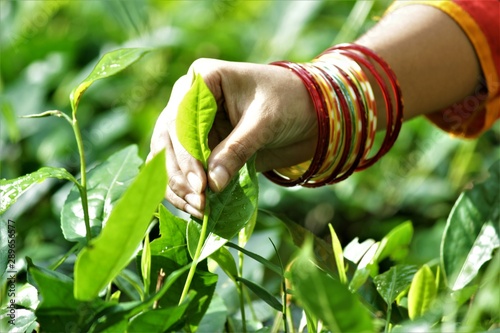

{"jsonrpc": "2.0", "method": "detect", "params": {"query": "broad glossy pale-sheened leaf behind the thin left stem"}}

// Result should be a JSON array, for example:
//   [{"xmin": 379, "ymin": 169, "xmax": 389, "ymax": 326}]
[{"xmin": 61, "ymin": 145, "xmax": 142, "ymax": 242}]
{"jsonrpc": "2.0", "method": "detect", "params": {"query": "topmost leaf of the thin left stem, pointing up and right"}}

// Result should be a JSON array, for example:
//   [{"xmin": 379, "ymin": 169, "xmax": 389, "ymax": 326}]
[{"xmin": 69, "ymin": 48, "xmax": 151, "ymax": 113}]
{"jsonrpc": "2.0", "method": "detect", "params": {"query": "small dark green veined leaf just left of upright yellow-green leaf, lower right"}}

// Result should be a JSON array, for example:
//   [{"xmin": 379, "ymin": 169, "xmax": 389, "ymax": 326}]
[{"xmin": 373, "ymin": 265, "xmax": 417, "ymax": 304}]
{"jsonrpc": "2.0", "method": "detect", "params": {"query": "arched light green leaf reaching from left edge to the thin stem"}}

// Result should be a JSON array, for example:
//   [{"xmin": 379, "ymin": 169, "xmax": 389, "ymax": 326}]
[{"xmin": 0, "ymin": 167, "xmax": 80, "ymax": 215}]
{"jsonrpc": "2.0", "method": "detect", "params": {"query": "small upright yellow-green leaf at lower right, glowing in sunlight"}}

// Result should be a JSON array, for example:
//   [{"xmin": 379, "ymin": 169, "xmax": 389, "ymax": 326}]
[{"xmin": 408, "ymin": 265, "xmax": 437, "ymax": 320}]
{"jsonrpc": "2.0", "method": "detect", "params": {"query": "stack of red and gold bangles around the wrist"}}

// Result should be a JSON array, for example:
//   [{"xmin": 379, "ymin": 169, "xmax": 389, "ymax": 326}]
[{"xmin": 265, "ymin": 44, "xmax": 403, "ymax": 187}]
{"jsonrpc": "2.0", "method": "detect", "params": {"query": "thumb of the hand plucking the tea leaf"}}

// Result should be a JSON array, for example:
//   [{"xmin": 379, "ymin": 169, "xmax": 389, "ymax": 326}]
[{"xmin": 208, "ymin": 122, "xmax": 263, "ymax": 192}]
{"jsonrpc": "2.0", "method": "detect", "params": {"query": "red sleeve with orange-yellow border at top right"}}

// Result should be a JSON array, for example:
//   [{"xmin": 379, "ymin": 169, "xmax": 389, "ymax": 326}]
[{"xmin": 391, "ymin": 0, "xmax": 500, "ymax": 138}]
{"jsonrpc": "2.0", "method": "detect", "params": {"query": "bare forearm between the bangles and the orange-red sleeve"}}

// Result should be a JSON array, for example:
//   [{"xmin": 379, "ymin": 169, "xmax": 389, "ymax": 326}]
[{"xmin": 357, "ymin": 5, "xmax": 481, "ymax": 126}]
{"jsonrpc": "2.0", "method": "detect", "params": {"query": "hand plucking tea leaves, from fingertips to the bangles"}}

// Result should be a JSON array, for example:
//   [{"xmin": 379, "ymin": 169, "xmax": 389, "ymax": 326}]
[{"xmin": 148, "ymin": 59, "xmax": 317, "ymax": 218}]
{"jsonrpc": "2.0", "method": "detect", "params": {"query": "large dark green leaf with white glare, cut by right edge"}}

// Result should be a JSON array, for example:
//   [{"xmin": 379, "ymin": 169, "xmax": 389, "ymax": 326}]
[{"xmin": 441, "ymin": 161, "xmax": 500, "ymax": 290}]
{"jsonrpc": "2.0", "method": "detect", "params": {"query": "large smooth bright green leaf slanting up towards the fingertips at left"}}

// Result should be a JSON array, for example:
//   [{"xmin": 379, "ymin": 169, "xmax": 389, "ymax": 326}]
[{"xmin": 74, "ymin": 152, "xmax": 166, "ymax": 300}]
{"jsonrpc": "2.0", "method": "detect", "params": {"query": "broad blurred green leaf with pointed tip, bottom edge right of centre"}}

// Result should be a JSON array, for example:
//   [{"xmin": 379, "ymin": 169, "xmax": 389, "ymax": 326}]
[{"xmin": 291, "ymin": 241, "xmax": 374, "ymax": 332}]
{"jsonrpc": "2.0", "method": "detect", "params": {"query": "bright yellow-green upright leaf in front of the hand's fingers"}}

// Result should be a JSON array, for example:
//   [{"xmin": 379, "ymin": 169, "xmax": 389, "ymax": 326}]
[{"xmin": 176, "ymin": 74, "xmax": 217, "ymax": 170}]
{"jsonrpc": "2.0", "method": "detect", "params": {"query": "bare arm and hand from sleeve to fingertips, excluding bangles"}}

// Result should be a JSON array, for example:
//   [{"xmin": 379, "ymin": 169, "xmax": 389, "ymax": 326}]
[{"xmin": 147, "ymin": 5, "xmax": 481, "ymax": 217}]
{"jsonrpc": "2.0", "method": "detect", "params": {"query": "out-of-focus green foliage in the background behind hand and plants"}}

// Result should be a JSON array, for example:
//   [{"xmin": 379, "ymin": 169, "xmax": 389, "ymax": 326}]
[{"xmin": 0, "ymin": 0, "xmax": 500, "ymax": 274}]
